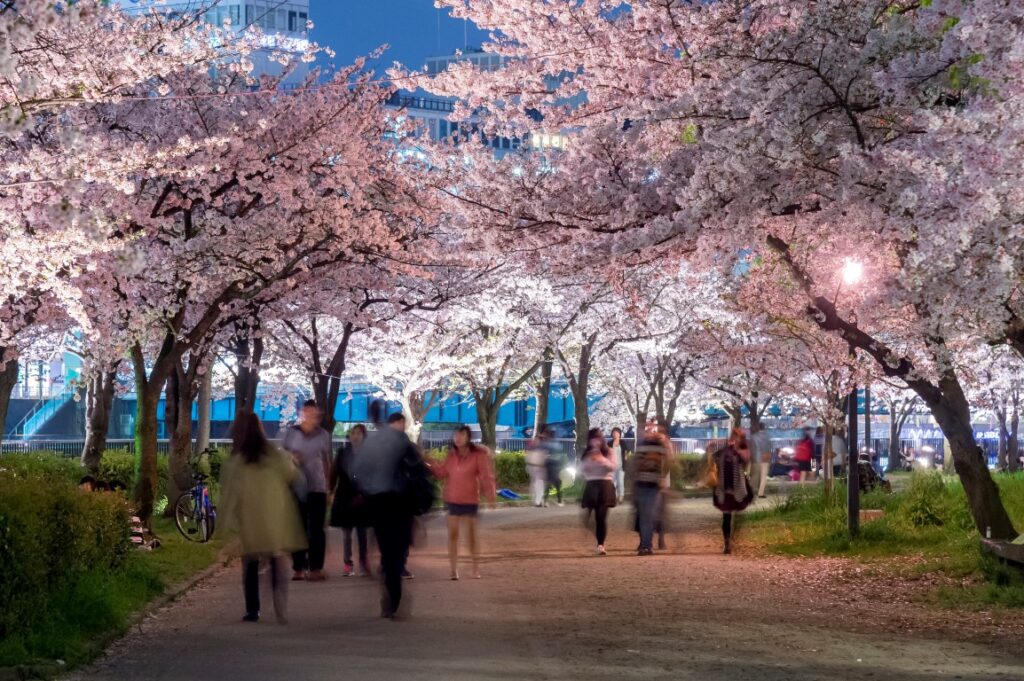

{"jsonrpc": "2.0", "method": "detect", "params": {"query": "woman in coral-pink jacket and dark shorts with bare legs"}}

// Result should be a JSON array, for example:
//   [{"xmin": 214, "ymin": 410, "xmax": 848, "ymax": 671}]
[{"xmin": 430, "ymin": 426, "xmax": 497, "ymax": 580}]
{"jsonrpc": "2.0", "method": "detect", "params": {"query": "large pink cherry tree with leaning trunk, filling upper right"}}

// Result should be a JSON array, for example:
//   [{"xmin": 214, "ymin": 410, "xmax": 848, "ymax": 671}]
[{"xmin": 425, "ymin": 0, "xmax": 1024, "ymax": 539}]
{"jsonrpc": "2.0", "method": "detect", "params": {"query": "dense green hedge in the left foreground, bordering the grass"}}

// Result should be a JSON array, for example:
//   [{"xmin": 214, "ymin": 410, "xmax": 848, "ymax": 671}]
[{"xmin": 0, "ymin": 460, "xmax": 131, "ymax": 639}]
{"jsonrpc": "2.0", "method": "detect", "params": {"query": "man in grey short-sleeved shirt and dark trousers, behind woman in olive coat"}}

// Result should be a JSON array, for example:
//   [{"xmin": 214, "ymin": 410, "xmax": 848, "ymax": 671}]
[{"xmin": 281, "ymin": 399, "xmax": 331, "ymax": 582}]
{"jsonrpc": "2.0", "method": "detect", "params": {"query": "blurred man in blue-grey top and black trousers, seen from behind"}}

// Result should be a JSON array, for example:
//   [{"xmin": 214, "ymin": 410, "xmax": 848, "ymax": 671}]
[{"xmin": 352, "ymin": 399, "xmax": 429, "ymax": 619}]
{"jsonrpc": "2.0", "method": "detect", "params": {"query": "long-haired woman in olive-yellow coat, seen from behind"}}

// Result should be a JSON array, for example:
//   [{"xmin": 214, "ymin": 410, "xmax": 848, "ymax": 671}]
[{"xmin": 220, "ymin": 412, "xmax": 306, "ymax": 624}]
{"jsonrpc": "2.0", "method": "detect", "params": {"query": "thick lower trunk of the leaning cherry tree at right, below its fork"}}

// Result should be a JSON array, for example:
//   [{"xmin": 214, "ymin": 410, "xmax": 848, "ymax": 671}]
[{"xmin": 929, "ymin": 391, "xmax": 1017, "ymax": 541}]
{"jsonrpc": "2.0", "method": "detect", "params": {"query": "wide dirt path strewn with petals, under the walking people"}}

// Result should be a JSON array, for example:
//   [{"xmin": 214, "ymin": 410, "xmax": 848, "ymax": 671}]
[{"xmin": 64, "ymin": 500, "xmax": 1024, "ymax": 681}]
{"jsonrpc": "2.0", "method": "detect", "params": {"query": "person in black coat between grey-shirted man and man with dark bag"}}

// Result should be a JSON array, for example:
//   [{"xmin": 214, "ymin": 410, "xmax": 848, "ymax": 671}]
[{"xmin": 331, "ymin": 423, "xmax": 370, "ymax": 577}]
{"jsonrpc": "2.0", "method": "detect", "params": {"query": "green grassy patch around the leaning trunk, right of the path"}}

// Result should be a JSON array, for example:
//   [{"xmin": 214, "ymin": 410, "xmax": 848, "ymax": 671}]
[{"xmin": 743, "ymin": 472, "xmax": 1024, "ymax": 607}]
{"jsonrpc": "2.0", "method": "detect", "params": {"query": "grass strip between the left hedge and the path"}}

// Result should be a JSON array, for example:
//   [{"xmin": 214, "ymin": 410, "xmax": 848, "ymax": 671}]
[{"xmin": 0, "ymin": 518, "xmax": 223, "ymax": 667}]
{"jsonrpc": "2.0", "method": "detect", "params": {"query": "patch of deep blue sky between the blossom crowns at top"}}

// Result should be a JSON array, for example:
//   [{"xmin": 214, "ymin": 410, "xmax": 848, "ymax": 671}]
[{"xmin": 309, "ymin": 0, "xmax": 486, "ymax": 73}]
